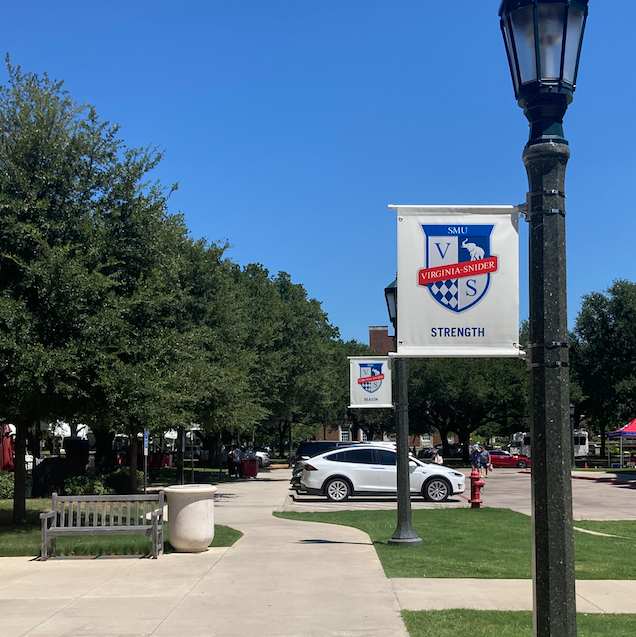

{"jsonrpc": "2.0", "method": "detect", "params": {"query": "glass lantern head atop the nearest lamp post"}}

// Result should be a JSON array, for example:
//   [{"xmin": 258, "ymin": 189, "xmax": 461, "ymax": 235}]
[{"xmin": 499, "ymin": 0, "xmax": 588, "ymax": 145}]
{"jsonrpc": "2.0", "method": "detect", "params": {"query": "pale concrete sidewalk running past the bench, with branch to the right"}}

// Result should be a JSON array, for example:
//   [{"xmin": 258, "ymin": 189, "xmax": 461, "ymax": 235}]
[{"xmin": 0, "ymin": 470, "xmax": 636, "ymax": 637}]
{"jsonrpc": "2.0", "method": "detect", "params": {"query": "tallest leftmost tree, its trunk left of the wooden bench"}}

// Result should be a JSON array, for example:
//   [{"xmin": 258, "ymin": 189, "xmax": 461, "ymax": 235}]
[{"xmin": 0, "ymin": 60, "xmax": 125, "ymax": 523}]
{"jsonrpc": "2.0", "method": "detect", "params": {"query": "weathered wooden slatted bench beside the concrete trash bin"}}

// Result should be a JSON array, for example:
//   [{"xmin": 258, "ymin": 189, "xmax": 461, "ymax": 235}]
[{"xmin": 40, "ymin": 491, "xmax": 164, "ymax": 560}]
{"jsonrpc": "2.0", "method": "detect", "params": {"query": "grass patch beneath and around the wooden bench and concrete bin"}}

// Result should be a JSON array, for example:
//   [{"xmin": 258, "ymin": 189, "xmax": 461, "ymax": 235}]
[{"xmin": 0, "ymin": 498, "xmax": 243, "ymax": 557}]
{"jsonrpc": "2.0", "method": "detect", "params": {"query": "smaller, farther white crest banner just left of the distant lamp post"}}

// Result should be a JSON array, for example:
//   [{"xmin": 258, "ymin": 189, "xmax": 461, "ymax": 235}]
[{"xmin": 349, "ymin": 356, "xmax": 393, "ymax": 408}]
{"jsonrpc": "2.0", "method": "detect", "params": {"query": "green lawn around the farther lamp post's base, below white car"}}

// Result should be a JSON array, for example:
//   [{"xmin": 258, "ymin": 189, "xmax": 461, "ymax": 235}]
[{"xmin": 275, "ymin": 508, "xmax": 636, "ymax": 579}]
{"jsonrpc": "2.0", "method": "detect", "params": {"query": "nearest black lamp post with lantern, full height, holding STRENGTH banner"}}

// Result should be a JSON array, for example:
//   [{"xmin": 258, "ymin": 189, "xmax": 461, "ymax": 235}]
[{"xmin": 499, "ymin": 0, "xmax": 588, "ymax": 637}]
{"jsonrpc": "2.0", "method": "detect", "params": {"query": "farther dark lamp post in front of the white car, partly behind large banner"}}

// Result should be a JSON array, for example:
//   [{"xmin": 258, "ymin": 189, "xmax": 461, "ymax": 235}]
[{"xmin": 384, "ymin": 279, "xmax": 422, "ymax": 546}]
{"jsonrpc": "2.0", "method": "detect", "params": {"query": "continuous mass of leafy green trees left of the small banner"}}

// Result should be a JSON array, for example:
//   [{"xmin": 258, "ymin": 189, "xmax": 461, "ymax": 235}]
[{"xmin": 0, "ymin": 60, "xmax": 358, "ymax": 521}]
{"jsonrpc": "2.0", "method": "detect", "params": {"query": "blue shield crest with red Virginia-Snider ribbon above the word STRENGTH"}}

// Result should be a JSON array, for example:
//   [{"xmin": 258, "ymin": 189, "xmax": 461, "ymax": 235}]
[{"xmin": 418, "ymin": 224, "xmax": 498, "ymax": 313}]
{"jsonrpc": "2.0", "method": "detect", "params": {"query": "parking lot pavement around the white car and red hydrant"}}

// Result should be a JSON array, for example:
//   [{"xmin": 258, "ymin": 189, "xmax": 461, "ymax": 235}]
[{"xmin": 282, "ymin": 469, "xmax": 636, "ymax": 520}]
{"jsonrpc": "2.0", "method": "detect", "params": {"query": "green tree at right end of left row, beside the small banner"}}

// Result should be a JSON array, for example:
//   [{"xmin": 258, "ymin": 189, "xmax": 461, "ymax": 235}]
[{"xmin": 236, "ymin": 264, "xmax": 338, "ymax": 454}]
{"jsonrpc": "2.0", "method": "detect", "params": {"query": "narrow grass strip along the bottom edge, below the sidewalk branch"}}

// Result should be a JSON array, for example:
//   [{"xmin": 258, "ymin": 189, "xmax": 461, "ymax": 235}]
[{"xmin": 402, "ymin": 609, "xmax": 636, "ymax": 637}]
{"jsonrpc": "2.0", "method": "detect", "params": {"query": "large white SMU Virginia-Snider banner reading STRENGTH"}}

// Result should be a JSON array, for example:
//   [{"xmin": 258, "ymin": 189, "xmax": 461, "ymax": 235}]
[{"xmin": 391, "ymin": 206, "xmax": 520, "ymax": 357}]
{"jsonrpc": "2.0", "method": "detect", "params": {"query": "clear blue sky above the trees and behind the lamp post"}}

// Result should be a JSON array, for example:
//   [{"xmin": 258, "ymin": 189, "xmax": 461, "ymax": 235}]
[{"xmin": 0, "ymin": 0, "xmax": 636, "ymax": 342}]
